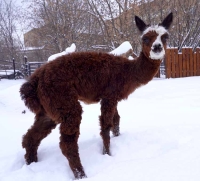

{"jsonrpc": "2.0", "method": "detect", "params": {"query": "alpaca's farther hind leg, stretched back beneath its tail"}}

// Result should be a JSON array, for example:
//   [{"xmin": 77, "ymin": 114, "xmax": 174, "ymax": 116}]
[{"xmin": 22, "ymin": 113, "xmax": 56, "ymax": 164}]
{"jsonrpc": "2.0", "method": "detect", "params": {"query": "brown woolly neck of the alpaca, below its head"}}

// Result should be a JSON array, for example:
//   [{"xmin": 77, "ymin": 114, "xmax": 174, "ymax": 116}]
[{"xmin": 130, "ymin": 52, "xmax": 161, "ymax": 84}]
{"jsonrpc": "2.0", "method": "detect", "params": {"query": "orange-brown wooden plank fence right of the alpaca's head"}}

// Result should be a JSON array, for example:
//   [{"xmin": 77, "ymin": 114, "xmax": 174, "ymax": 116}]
[{"xmin": 165, "ymin": 48, "xmax": 200, "ymax": 78}]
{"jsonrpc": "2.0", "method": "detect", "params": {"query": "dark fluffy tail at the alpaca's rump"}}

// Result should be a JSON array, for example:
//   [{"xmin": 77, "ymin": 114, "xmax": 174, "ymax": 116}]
[{"xmin": 20, "ymin": 77, "xmax": 41, "ymax": 113}]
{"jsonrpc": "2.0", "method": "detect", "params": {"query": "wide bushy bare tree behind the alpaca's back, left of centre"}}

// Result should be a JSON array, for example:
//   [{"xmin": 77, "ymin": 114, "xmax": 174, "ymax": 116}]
[{"xmin": 24, "ymin": 0, "xmax": 105, "ymax": 52}]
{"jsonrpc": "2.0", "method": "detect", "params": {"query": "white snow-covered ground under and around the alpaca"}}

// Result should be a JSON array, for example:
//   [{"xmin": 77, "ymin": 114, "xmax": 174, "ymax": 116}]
[{"xmin": 0, "ymin": 77, "xmax": 200, "ymax": 181}]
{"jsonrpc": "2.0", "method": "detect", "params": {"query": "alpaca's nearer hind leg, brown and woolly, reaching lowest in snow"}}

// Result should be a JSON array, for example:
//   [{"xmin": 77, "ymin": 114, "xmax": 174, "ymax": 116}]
[{"xmin": 60, "ymin": 99, "xmax": 86, "ymax": 179}]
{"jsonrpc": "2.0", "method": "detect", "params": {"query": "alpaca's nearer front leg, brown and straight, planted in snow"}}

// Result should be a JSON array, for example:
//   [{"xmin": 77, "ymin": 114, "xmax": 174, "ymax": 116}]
[{"xmin": 100, "ymin": 99, "xmax": 117, "ymax": 155}]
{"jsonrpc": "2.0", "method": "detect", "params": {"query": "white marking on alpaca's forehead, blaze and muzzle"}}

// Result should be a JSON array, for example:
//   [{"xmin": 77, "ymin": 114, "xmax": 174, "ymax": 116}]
[{"xmin": 142, "ymin": 25, "xmax": 168, "ymax": 60}]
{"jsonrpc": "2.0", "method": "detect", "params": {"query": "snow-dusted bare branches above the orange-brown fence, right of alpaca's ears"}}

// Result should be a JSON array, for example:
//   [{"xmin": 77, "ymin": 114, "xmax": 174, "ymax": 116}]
[{"xmin": 172, "ymin": 0, "xmax": 200, "ymax": 50}]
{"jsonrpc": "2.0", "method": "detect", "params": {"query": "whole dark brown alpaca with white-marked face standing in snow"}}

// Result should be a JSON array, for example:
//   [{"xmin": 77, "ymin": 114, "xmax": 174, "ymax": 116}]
[{"xmin": 20, "ymin": 13, "xmax": 173, "ymax": 179}]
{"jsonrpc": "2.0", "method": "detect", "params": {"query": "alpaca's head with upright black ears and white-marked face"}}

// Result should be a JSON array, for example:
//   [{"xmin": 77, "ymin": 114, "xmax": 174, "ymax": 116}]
[{"xmin": 135, "ymin": 13, "xmax": 173, "ymax": 60}]
